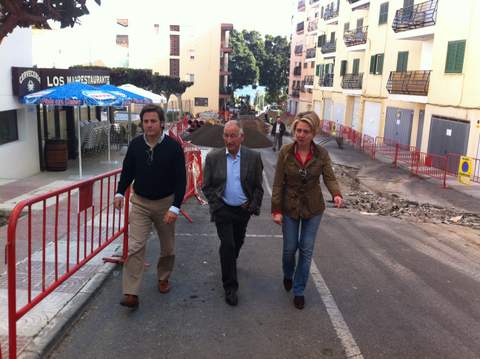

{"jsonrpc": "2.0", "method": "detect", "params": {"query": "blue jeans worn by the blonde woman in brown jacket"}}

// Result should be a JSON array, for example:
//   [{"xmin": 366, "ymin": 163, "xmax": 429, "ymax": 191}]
[{"xmin": 282, "ymin": 214, "xmax": 322, "ymax": 296}]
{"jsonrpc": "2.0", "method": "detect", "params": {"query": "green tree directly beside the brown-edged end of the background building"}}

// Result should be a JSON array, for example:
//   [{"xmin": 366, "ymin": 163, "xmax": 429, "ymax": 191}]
[{"xmin": 229, "ymin": 30, "xmax": 259, "ymax": 89}]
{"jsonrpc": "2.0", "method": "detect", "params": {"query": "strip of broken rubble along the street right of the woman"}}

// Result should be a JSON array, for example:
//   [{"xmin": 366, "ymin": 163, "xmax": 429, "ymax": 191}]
[{"xmin": 335, "ymin": 164, "xmax": 480, "ymax": 229}]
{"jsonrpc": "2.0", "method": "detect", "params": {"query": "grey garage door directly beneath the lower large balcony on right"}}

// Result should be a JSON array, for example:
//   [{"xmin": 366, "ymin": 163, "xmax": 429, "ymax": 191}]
[{"xmin": 383, "ymin": 107, "xmax": 413, "ymax": 145}]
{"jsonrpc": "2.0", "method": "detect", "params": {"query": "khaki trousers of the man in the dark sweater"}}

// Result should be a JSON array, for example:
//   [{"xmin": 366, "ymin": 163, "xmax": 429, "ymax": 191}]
[{"xmin": 122, "ymin": 194, "xmax": 175, "ymax": 295}]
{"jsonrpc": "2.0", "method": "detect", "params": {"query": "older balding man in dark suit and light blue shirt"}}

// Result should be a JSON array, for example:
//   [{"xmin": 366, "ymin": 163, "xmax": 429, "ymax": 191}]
[{"xmin": 203, "ymin": 121, "xmax": 263, "ymax": 305}]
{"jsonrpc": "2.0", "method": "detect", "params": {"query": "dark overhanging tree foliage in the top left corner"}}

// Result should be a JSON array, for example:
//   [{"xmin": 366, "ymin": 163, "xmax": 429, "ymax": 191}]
[{"xmin": 0, "ymin": 0, "xmax": 101, "ymax": 43}]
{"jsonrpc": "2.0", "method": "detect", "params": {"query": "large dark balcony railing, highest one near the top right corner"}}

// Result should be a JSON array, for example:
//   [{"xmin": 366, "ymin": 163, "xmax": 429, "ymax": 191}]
[{"xmin": 392, "ymin": 0, "xmax": 438, "ymax": 32}]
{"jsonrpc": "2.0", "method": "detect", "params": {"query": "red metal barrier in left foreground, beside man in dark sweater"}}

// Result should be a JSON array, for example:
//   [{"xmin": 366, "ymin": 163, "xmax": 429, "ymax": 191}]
[{"xmin": 6, "ymin": 170, "xmax": 130, "ymax": 359}]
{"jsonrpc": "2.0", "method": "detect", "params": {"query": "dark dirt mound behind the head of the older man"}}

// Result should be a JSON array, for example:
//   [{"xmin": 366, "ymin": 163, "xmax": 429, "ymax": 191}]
[{"xmin": 190, "ymin": 125, "xmax": 272, "ymax": 148}]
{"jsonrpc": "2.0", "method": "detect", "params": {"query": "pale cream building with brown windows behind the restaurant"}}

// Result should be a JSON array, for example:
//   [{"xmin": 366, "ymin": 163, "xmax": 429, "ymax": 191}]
[{"xmin": 33, "ymin": 2, "xmax": 233, "ymax": 113}]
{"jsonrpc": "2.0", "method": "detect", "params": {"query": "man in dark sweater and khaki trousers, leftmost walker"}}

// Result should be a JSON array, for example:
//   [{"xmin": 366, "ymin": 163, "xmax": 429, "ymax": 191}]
[{"xmin": 115, "ymin": 105, "xmax": 186, "ymax": 308}]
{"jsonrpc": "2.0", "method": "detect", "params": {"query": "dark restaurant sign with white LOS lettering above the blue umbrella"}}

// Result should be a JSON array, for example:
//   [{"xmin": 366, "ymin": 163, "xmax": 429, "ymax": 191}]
[{"xmin": 12, "ymin": 67, "xmax": 110, "ymax": 97}]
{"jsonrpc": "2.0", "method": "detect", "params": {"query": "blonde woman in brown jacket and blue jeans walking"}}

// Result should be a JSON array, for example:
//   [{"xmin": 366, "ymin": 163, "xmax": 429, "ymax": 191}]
[{"xmin": 272, "ymin": 111, "xmax": 343, "ymax": 309}]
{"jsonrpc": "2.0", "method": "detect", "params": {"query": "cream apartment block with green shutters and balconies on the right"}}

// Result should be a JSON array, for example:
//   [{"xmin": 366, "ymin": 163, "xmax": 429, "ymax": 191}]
[{"xmin": 289, "ymin": 0, "xmax": 480, "ymax": 158}]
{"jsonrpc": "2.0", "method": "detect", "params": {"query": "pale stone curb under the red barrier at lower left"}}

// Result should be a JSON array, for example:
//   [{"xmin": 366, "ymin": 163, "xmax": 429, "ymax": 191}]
[{"xmin": 18, "ymin": 246, "xmax": 121, "ymax": 359}]
